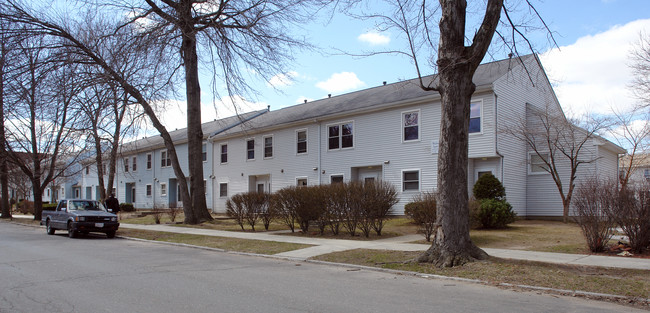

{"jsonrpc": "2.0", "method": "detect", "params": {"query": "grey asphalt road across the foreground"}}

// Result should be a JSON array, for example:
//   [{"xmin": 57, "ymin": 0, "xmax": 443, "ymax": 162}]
[{"xmin": 0, "ymin": 222, "xmax": 640, "ymax": 313}]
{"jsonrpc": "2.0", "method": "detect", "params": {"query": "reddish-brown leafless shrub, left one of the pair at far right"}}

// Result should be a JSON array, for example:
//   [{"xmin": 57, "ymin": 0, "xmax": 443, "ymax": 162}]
[{"xmin": 573, "ymin": 178, "xmax": 618, "ymax": 252}]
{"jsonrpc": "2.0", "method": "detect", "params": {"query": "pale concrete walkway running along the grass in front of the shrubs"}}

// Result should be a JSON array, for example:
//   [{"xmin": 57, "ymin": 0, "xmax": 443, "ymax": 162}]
[{"xmin": 120, "ymin": 223, "xmax": 650, "ymax": 270}]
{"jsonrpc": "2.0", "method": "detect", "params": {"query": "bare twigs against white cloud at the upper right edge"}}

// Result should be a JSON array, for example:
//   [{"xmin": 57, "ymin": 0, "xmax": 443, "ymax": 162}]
[{"xmin": 630, "ymin": 33, "xmax": 650, "ymax": 107}]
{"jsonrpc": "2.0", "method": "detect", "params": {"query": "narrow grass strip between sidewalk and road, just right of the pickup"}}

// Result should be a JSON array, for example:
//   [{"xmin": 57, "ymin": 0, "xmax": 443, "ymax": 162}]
[{"xmin": 117, "ymin": 228, "xmax": 311, "ymax": 255}]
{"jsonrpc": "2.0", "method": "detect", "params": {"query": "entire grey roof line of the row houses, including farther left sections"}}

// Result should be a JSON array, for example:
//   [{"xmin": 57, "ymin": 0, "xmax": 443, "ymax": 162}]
[{"xmin": 122, "ymin": 55, "xmax": 534, "ymax": 153}]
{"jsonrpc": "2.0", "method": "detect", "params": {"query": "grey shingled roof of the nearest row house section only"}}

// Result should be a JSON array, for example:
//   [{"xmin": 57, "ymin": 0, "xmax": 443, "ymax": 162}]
[{"xmin": 211, "ymin": 55, "xmax": 533, "ymax": 139}]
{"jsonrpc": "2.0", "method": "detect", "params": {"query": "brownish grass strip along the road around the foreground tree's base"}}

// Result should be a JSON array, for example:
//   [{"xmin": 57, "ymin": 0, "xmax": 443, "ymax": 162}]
[{"xmin": 314, "ymin": 249, "xmax": 650, "ymax": 299}]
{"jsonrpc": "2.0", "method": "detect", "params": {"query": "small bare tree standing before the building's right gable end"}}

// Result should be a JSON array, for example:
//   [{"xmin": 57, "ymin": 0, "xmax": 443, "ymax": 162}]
[{"xmin": 501, "ymin": 104, "xmax": 609, "ymax": 223}]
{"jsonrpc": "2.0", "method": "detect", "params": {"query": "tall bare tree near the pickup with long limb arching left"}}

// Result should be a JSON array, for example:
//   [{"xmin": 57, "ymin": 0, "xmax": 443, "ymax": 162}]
[{"xmin": 0, "ymin": 0, "xmax": 328, "ymax": 224}]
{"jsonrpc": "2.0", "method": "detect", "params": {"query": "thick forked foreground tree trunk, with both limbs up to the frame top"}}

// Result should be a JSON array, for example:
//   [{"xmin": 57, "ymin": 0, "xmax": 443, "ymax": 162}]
[{"xmin": 417, "ymin": 0, "xmax": 503, "ymax": 267}]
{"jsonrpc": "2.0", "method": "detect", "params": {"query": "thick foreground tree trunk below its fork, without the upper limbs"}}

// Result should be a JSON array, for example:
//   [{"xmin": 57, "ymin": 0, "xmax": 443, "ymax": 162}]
[{"xmin": 418, "ymin": 62, "xmax": 487, "ymax": 267}]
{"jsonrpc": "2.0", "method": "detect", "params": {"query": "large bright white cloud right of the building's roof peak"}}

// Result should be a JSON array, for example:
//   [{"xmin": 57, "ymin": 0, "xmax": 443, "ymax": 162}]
[{"xmin": 540, "ymin": 19, "xmax": 650, "ymax": 115}]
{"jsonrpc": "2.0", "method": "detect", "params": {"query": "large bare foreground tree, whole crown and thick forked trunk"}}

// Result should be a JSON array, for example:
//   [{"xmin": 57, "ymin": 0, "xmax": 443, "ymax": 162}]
[{"xmin": 344, "ymin": 0, "xmax": 552, "ymax": 267}]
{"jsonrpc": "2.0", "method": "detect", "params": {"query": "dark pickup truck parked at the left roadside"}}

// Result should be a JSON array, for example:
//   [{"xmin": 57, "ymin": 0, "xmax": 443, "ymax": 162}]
[{"xmin": 41, "ymin": 199, "xmax": 120, "ymax": 238}]
